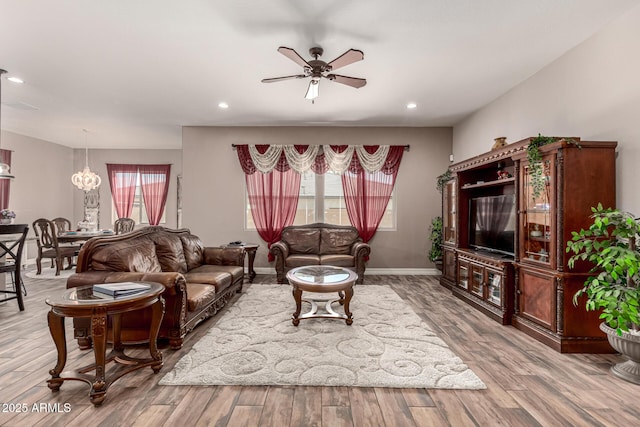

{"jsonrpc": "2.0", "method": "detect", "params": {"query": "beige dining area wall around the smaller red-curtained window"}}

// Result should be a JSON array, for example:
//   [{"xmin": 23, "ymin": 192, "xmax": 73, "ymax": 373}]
[{"xmin": 75, "ymin": 149, "xmax": 182, "ymax": 232}]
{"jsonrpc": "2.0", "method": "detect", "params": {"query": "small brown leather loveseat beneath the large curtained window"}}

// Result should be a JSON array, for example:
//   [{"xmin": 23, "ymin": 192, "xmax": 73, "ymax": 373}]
[{"xmin": 270, "ymin": 223, "xmax": 371, "ymax": 284}]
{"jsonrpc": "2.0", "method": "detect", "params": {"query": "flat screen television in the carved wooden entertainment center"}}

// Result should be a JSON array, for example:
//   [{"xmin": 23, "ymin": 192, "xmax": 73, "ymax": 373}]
[{"xmin": 469, "ymin": 194, "xmax": 516, "ymax": 256}]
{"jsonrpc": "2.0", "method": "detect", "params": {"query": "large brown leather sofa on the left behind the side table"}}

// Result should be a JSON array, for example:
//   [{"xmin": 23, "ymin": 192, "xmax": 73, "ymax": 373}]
[{"xmin": 67, "ymin": 226, "xmax": 244, "ymax": 349}]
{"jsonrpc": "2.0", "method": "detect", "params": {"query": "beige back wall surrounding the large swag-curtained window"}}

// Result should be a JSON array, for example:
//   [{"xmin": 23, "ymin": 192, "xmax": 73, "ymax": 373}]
[{"xmin": 182, "ymin": 127, "xmax": 451, "ymax": 269}]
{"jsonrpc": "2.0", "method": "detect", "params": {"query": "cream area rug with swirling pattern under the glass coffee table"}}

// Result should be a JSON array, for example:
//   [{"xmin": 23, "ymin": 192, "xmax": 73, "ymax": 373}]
[{"xmin": 160, "ymin": 285, "xmax": 486, "ymax": 389}]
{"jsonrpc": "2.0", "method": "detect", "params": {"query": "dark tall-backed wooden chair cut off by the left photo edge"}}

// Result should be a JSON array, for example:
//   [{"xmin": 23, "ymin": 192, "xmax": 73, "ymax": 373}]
[{"xmin": 0, "ymin": 224, "xmax": 29, "ymax": 311}]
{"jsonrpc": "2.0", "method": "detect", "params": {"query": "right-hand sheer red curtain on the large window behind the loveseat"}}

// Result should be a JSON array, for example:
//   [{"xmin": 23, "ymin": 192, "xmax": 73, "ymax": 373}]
[{"xmin": 342, "ymin": 146, "xmax": 404, "ymax": 242}]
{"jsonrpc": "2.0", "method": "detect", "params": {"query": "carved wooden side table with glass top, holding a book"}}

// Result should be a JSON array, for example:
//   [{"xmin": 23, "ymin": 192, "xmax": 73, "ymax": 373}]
[{"xmin": 46, "ymin": 282, "xmax": 164, "ymax": 406}]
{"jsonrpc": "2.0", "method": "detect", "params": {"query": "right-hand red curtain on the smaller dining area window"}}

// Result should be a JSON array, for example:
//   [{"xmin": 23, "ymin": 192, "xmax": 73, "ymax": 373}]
[{"xmin": 138, "ymin": 165, "xmax": 171, "ymax": 225}]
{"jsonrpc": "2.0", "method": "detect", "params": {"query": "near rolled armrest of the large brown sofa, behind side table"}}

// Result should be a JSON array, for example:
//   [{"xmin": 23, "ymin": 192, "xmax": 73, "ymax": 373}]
[{"xmin": 67, "ymin": 270, "xmax": 186, "ymax": 295}]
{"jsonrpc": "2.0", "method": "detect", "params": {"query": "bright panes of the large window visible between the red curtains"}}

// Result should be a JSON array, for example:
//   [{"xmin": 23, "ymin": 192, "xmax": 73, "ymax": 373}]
[{"xmin": 245, "ymin": 171, "xmax": 395, "ymax": 230}]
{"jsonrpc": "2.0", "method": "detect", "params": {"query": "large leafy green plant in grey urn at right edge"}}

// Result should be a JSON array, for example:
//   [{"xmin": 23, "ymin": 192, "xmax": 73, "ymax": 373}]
[{"xmin": 567, "ymin": 204, "xmax": 640, "ymax": 384}]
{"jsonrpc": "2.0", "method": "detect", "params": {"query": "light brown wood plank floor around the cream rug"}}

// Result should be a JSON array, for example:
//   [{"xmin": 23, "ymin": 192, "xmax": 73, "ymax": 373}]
[{"xmin": 0, "ymin": 275, "xmax": 640, "ymax": 427}]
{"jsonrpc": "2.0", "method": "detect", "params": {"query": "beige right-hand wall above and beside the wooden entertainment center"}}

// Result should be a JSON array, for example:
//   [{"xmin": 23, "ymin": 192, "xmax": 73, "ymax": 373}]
[{"xmin": 453, "ymin": 7, "xmax": 640, "ymax": 215}]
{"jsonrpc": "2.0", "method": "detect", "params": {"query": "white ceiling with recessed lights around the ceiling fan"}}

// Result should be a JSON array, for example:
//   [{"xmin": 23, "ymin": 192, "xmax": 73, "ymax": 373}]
[{"xmin": 0, "ymin": 0, "xmax": 640, "ymax": 148}]
